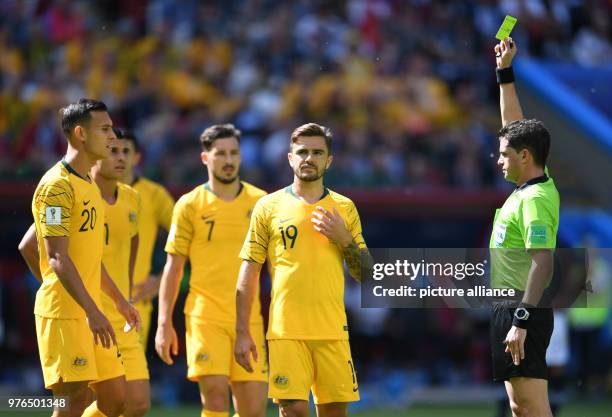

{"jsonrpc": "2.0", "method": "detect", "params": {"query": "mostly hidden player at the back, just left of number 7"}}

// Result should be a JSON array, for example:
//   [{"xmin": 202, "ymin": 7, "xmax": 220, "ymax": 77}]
[{"xmin": 115, "ymin": 128, "xmax": 174, "ymax": 351}]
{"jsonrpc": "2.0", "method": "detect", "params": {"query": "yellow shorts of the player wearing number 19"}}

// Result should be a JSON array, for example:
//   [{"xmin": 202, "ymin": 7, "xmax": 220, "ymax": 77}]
[{"xmin": 268, "ymin": 339, "xmax": 359, "ymax": 404}]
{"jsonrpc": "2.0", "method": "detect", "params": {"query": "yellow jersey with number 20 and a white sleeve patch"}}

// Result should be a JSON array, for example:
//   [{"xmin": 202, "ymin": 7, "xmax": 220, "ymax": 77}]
[{"xmin": 32, "ymin": 161, "xmax": 104, "ymax": 319}]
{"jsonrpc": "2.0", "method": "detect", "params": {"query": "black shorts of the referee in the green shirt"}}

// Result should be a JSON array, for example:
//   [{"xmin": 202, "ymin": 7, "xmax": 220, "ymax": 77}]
[{"xmin": 490, "ymin": 301, "xmax": 554, "ymax": 381}]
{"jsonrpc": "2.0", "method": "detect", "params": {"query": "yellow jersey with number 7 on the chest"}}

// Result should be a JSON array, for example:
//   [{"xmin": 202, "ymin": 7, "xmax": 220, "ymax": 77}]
[{"xmin": 166, "ymin": 182, "xmax": 266, "ymax": 324}]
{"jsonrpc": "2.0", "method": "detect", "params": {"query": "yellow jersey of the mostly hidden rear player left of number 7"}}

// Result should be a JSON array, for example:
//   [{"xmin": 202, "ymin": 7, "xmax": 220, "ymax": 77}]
[{"xmin": 132, "ymin": 177, "xmax": 174, "ymax": 285}]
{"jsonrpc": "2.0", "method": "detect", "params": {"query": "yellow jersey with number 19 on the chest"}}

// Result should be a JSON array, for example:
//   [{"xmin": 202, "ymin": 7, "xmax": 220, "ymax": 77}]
[{"xmin": 240, "ymin": 186, "xmax": 366, "ymax": 340}]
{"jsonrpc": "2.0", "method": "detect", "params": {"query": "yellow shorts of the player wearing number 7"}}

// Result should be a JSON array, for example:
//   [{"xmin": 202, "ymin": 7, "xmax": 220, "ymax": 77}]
[{"xmin": 185, "ymin": 315, "xmax": 268, "ymax": 382}]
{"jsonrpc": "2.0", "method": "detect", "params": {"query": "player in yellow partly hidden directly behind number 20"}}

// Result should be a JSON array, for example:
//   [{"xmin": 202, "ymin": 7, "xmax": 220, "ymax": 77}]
[{"xmin": 92, "ymin": 134, "xmax": 150, "ymax": 417}]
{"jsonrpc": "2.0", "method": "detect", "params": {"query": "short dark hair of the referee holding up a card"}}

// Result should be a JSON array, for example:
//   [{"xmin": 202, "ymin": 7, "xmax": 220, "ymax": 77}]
[{"xmin": 497, "ymin": 119, "xmax": 550, "ymax": 168}]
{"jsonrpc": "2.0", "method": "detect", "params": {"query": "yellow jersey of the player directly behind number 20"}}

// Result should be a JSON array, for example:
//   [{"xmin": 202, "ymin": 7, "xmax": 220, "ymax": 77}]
[{"xmin": 102, "ymin": 183, "xmax": 140, "ymax": 322}]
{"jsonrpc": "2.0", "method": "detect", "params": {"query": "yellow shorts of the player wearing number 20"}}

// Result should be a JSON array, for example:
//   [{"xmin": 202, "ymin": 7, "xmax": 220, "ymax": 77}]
[{"xmin": 35, "ymin": 316, "xmax": 125, "ymax": 389}]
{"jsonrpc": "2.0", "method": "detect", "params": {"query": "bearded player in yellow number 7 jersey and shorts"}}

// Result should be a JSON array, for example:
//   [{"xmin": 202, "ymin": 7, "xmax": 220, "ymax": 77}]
[{"xmin": 155, "ymin": 124, "xmax": 268, "ymax": 417}]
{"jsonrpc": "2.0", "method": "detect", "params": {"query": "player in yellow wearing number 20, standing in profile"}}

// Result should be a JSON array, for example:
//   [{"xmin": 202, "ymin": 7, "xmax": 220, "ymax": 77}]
[{"xmin": 20, "ymin": 99, "xmax": 139, "ymax": 417}]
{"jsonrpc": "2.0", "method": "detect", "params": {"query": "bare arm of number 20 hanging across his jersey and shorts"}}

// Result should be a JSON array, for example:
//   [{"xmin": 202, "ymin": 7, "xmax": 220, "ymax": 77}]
[{"xmin": 44, "ymin": 236, "xmax": 117, "ymax": 348}]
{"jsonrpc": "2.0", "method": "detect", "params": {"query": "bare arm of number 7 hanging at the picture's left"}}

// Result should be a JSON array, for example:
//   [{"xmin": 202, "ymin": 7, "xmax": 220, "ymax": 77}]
[{"xmin": 155, "ymin": 253, "xmax": 187, "ymax": 365}]
